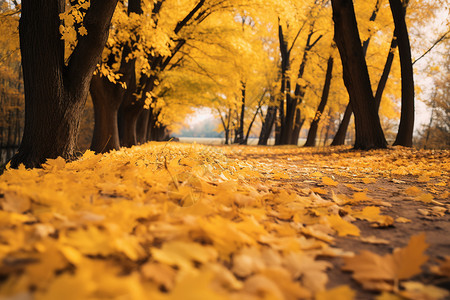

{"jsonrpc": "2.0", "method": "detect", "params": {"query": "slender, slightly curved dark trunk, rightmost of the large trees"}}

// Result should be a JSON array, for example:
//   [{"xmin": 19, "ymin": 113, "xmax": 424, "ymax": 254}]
[{"xmin": 389, "ymin": 0, "xmax": 414, "ymax": 147}]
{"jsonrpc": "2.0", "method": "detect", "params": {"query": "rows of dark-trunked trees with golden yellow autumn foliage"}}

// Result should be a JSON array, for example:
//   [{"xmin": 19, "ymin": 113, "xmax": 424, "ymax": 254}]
[{"xmin": 0, "ymin": 0, "xmax": 450, "ymax": 167}]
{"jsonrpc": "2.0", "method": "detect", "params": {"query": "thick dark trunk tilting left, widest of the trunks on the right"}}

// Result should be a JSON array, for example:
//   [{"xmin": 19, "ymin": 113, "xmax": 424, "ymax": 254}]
[{"xmin": 331, "ymin": 0, "xmax": 387, "ymax": 149}]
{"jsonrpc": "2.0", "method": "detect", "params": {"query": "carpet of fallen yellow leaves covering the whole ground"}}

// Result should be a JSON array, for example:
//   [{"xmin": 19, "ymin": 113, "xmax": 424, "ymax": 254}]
[{"xmin": 0, "ymin": 143, "xmax": 450, "ymax": 300}]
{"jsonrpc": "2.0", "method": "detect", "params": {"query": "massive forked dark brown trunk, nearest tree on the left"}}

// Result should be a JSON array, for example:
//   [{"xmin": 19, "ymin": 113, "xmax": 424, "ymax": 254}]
[{"xmin": 11, "ymin": 0, "xmax": 117, "ymax": 168}]
